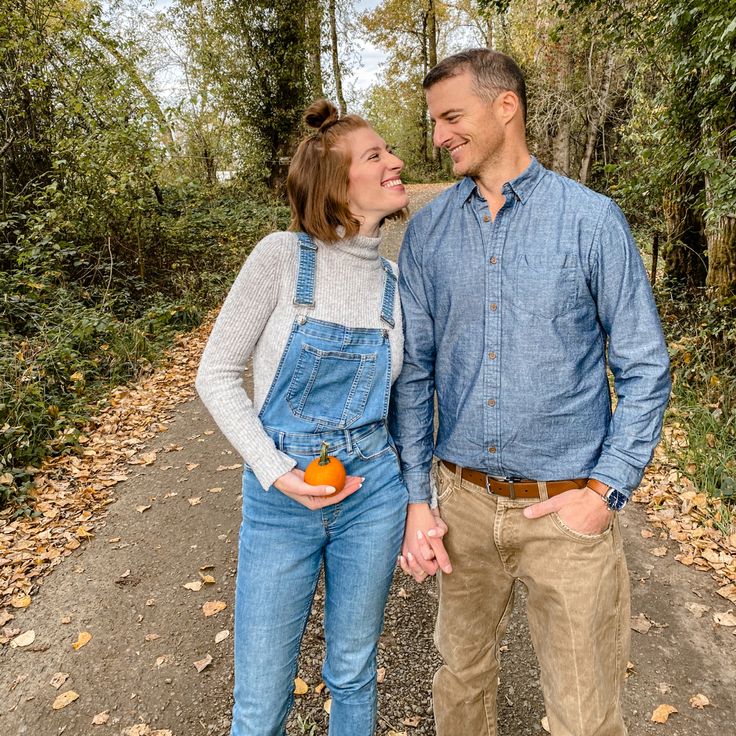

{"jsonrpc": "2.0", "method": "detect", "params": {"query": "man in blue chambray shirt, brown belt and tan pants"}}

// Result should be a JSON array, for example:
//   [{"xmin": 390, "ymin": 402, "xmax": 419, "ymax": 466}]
[{"xmin": 392, "ymin": 49, "xmax": 670, "ymax": 736}]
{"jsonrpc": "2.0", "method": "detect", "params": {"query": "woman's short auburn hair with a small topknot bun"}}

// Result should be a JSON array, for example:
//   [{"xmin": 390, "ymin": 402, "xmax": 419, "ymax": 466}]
[{"xmin": 286, "ymin": 100, "xmax": 405, "ymax": 243}]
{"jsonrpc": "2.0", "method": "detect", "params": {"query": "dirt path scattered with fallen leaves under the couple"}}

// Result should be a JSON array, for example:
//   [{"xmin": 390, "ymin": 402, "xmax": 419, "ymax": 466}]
[{"xmin": 0, "ymin": 185, "xmax": 736, "ymax": 736}]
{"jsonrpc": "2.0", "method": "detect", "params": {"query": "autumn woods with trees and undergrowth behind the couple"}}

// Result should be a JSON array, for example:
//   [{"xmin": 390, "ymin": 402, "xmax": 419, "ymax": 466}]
[{"xmin": 0, "ymin": 0, "xmax": 736, "ymax": 513}]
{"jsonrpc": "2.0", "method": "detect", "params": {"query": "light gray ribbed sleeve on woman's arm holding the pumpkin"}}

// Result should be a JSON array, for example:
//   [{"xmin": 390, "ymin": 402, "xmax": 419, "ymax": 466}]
[{"xmin": 195, "ymin": 233, "xmax": 296, "ymax": 489}]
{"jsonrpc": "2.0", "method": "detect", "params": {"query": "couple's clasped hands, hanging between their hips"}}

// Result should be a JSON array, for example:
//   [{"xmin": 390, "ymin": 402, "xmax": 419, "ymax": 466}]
[{"xmin": 399, "ymin": 503, "xmax": 452, "ymax": 583}]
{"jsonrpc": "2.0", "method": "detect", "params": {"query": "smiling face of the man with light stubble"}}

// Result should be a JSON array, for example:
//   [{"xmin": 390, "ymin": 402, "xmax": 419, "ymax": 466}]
[{"xmin": 427, "ymin": 71, "xmax": 505, "ymax": 177}]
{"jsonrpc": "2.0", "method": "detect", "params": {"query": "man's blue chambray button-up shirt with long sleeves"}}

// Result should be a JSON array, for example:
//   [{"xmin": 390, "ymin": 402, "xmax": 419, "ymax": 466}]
[{"xmin": 390, "ymin": 158, "xmax": 670, "ymax": 503}]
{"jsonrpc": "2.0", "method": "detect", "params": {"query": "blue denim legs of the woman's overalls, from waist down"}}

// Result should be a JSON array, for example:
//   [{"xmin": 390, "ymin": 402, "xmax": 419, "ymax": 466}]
[{"xmin": 231, "ymin": 432, "xmax": 407, "ymax": 736}]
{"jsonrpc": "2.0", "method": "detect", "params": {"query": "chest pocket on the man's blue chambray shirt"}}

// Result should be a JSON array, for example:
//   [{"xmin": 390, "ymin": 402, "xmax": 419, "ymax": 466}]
[{"xmin": 503, "ymin": 253, "xmax": 581, "ymax": 319}]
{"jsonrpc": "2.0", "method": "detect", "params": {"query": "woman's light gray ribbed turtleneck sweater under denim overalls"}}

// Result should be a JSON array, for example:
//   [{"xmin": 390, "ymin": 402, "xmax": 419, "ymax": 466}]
[{"xmin": 196, "ymin": 232, "xmax": 403, "ymax": 488}]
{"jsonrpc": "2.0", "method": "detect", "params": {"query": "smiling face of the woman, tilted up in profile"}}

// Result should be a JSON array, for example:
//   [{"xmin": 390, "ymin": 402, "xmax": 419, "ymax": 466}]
[{"xmin": 341, "ymin": 127, "xmax": 409, "ymax": 235}]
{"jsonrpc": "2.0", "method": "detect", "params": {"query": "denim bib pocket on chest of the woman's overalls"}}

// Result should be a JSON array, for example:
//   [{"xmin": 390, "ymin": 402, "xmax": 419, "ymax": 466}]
[{"xmin": 286, "ymin": 344, "xmax": 378, "ymax": 429}]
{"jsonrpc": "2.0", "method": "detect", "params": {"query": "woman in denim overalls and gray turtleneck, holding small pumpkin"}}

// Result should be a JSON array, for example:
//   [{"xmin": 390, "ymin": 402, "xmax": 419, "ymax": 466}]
[{"xmin": 197, "ymin": 100, "xmax": 408, "ymax": 736}]
